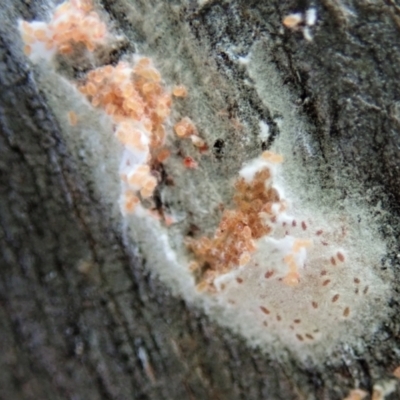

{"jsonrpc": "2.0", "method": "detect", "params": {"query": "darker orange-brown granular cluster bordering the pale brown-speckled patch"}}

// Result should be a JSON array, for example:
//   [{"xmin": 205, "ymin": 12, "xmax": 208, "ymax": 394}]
[{"xmin": 186, "ymin": 168, "xmax": 280, "ymax": 290}]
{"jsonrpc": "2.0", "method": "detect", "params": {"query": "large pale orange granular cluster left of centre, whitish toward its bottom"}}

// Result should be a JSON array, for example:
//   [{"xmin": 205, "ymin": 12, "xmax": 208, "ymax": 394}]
[{"xmin": 79, "ymin": 58, "xmax": 172, "ymax": 206}]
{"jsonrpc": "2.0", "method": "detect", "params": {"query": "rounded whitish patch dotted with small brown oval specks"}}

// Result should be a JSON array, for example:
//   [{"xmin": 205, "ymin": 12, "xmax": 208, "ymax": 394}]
[{"xmin": 184, "ymin": 154, "xmax": 384, "ymax": 354}]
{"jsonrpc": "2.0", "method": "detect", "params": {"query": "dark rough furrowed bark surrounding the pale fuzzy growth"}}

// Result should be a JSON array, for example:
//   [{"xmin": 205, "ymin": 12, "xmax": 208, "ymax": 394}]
[{"xmin": 0, "ymin": 0, "xmax": 400, "ymax": 400}]
